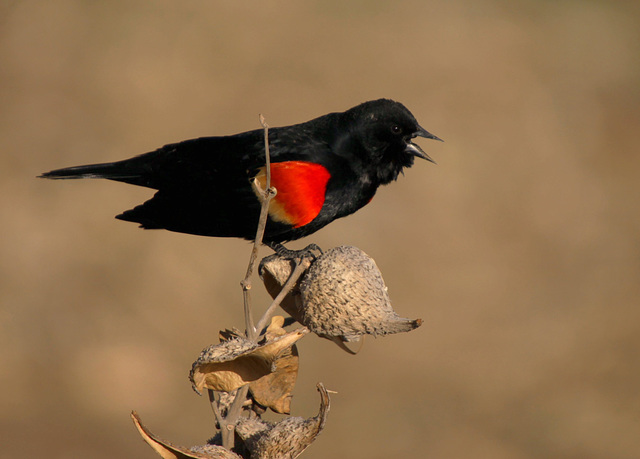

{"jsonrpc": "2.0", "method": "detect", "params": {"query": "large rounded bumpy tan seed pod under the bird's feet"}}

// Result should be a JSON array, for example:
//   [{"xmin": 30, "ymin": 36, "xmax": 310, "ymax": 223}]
[{"xmin": 260, "ymin": 246, "xmax": 422, "ymax": 350}]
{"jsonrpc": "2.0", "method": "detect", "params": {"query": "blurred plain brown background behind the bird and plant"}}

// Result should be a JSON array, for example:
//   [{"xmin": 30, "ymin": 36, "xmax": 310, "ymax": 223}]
[{"xmin": 0, "ymin": 0, "xmax": 640, "ymax": 459}]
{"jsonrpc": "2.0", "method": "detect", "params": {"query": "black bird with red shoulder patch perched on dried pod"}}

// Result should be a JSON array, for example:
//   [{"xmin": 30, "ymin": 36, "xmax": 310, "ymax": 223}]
[{"xmin": 41, "ymin": 99, "xmax": 440, "ymax": 246}]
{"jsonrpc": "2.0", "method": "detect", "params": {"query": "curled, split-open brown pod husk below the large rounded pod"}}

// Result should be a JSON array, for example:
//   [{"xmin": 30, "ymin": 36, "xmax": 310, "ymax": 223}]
[{"xmin": 189, "ymin": 328, "xmax": 309, "ymax": 393}]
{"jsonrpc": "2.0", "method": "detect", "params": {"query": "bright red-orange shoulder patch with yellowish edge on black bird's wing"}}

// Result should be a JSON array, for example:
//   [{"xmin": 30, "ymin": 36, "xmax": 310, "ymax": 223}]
[{"xmin": 255, "ymin": 161, "xmax": 330, "ymax": 228}]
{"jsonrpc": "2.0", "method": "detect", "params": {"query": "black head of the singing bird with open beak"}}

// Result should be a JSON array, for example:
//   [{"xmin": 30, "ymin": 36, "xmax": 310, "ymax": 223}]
[{"xmin": 345, "ymin": 99, "xmax": 442, "ymax": 184}]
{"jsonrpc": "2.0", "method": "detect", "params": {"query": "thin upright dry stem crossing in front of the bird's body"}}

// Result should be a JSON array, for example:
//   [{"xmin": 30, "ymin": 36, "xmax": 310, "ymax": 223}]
[{"xmin": 240, "ymin": 115, "xmax": 277, "ymax": 341}]
